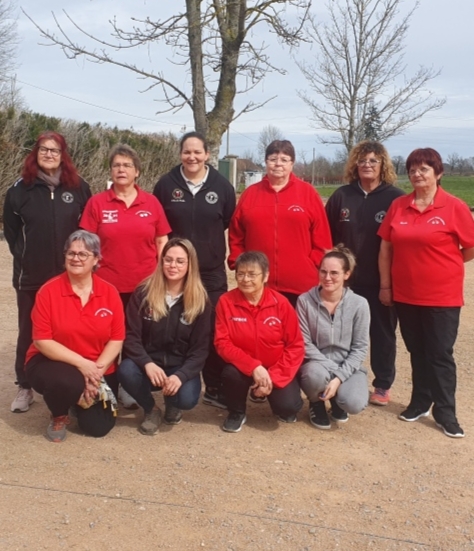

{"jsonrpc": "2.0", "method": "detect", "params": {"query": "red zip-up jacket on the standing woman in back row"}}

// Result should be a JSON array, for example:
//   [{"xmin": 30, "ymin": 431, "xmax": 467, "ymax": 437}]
[{"xmin": 228, "ymin": 174, "xmax": 332, "ymax": 295}]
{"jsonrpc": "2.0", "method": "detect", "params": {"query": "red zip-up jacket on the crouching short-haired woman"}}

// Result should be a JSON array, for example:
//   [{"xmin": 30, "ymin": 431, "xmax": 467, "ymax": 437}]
[{"xmin": 214, "ymin": 288, "xmax": 304, "ymax": 388}]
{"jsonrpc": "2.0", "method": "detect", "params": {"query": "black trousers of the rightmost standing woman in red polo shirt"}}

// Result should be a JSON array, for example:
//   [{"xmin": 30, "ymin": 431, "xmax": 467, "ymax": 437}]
[{"xmin": 395, "ymin": 302, "xmax": 461, "ymax": 423}]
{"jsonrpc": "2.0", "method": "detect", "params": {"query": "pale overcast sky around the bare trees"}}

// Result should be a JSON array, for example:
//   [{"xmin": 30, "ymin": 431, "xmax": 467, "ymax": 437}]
[{"xmin": 13, "ymin": 0, "xmax": 474, "ymax": 159}]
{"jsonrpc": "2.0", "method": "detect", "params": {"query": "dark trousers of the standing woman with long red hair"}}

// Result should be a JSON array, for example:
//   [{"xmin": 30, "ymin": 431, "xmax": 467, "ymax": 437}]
[{"xmin": 15, "ymin": 290, "xmax": 38, "ymax": 388}]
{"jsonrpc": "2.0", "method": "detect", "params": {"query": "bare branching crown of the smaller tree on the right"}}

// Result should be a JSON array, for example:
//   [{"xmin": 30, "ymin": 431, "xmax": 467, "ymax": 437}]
[{"xmin": 297, "ymin": 0, "xmax": 446, "ymax": 151}]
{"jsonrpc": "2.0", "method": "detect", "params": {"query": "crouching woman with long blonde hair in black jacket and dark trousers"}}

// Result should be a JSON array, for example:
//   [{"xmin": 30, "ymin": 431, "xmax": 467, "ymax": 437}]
[{"xmin": 118, "ymin": 238, "xmax": 211, "ymax": 436}]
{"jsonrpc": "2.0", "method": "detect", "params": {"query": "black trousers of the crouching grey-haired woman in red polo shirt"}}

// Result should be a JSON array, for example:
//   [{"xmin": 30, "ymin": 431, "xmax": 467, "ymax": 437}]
[{"xmin": 26, "ymin": 354, "xmax": 118, "ymax": 437}]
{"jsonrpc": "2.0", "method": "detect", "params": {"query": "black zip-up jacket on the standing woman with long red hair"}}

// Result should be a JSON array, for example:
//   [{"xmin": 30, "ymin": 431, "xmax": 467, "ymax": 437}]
[{"xmin": 3, "ymin": 178, "xmax": 91, "ymax": 291}]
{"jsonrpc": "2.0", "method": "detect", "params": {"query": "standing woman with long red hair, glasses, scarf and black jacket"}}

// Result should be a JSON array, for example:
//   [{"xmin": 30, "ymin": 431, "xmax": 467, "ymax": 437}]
[{"xmin": 3, "ymin": 132, "xmax": 91, "ymax": 413}]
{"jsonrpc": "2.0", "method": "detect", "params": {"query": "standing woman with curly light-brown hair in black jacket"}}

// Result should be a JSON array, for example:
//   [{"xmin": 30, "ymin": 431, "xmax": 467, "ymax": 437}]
[{"xmin": 326, "ymin": 140, "xmax": 404, "ymax": 406}]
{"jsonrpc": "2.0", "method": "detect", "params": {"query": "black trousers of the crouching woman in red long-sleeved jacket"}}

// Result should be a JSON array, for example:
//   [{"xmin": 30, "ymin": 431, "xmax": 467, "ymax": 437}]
[{"xmin": 222, "ymin": 364, "xmax": 303, "ymax": 417}]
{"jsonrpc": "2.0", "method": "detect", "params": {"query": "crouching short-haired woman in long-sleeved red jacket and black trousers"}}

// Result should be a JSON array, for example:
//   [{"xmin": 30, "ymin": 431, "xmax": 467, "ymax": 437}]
[{"xmin": 214, "ymin": 251, "xmax": 304, "ymax": 432}]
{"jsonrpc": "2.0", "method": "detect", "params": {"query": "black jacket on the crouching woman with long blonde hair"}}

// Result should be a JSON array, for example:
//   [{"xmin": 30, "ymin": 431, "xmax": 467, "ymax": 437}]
[{"xmin": 123, "ymin": 286, "xmax": 211, "ymax": 383}]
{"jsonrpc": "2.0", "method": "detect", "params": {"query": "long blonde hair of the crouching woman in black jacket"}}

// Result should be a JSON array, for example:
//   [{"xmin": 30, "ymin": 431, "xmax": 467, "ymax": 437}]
[{"xmin": 142, "ymin": 237, "xmax": 208, "ymax": 323}]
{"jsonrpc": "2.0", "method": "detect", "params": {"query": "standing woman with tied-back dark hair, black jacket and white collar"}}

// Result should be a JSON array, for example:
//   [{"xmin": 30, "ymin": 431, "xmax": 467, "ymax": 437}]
[{"xmin": 153, "ymin": 132, "xmax": 236, "ymax": 408}]
